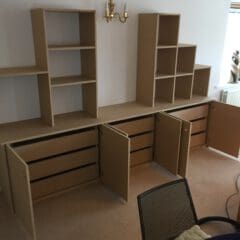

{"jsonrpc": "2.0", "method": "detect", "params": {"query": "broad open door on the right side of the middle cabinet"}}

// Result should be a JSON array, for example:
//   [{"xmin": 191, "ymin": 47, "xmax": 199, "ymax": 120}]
[{"xmin": 154, "ymin": 113, "xmax": 182, "ymax": 175}]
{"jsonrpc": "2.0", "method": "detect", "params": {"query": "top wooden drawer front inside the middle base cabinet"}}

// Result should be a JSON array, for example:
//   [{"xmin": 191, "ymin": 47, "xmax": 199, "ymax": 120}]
[{"xmin": 114, "ymin": 117, "xmax": 154, "ymax": 136}]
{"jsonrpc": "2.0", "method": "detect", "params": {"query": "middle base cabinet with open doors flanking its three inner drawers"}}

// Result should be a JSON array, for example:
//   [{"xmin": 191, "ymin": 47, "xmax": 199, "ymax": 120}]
[{"xmin": 100, "ymin": 112, "xmax": 191, "ymax": 201}]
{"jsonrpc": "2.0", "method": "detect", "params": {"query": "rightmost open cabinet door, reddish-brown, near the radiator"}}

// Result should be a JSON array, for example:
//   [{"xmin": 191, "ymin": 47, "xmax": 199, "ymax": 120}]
[{"xmin": 207, "ymin": 102, "xmax": 240, "ymax": 158}]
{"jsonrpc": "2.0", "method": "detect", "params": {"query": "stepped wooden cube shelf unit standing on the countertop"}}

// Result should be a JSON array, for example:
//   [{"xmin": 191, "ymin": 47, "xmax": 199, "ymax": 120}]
[{"xmin": 137, "ymin": 13, "xmax": 210, "ymax": 107}]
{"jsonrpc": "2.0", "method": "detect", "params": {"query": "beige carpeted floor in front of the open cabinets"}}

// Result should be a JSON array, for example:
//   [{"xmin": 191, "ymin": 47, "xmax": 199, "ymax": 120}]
[{"xmin": 0, "ymin": 148, "xmax": 240, "ymax": 240}]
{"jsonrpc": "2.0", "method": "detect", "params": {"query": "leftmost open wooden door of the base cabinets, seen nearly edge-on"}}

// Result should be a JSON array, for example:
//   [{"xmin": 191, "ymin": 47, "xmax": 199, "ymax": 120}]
[{"xmin": 7, "ymin": 145, "xmax": 36, "ymax": 240}]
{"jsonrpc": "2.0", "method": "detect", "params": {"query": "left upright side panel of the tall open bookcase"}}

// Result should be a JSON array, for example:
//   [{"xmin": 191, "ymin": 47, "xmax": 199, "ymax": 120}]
[{"xmin": 31, "ymin": 9, "xmax": 54, "ymax": 126}]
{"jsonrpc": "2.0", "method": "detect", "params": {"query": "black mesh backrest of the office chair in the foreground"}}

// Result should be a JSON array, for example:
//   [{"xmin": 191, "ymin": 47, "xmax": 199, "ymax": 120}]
[{"xmin": 138, "ymin": 179, "xmax": 197, "ymax": 240}]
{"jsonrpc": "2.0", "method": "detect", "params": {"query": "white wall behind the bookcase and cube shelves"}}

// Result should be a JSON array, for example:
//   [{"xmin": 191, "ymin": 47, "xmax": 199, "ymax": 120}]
[{"xmin": 0, "ymin": 0, "xmax": 230, "ymax": 123}]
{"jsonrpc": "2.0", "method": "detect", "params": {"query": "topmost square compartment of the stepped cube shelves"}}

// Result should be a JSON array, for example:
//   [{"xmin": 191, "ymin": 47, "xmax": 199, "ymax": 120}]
[{"xmin": 158, "ymin": 14, "xmax": 180, "ymax": 47}]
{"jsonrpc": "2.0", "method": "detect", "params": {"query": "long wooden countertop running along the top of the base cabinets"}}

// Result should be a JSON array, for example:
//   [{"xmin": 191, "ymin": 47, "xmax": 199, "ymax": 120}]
[{"xmin": 0, "ymin": 96, "xmax": 212, "ymax": 144}]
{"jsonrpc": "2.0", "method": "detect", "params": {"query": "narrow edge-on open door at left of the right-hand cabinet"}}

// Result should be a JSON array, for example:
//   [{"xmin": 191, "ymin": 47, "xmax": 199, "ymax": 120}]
[{"xmin": 178, "ymin": 120, "xmax": 192, "ymax": 177}]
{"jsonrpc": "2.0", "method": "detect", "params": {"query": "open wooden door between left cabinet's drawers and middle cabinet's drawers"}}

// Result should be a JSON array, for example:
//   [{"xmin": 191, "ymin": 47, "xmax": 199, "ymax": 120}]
[{"xmin": 100, "ymin": 125, "xmax": 130, "ymax": 201}]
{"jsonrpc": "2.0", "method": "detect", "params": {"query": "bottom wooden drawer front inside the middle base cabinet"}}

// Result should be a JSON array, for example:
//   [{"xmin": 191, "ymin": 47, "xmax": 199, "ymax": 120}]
[{"xmin": 130, "ymin": 147, "xmax": 153, "ymax": 167}]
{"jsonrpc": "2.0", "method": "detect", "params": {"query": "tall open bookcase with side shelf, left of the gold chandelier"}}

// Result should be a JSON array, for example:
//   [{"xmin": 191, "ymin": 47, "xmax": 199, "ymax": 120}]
[{"xmin": 0, "ymin": 9, "xmax": 98, "ymax": 126}]
